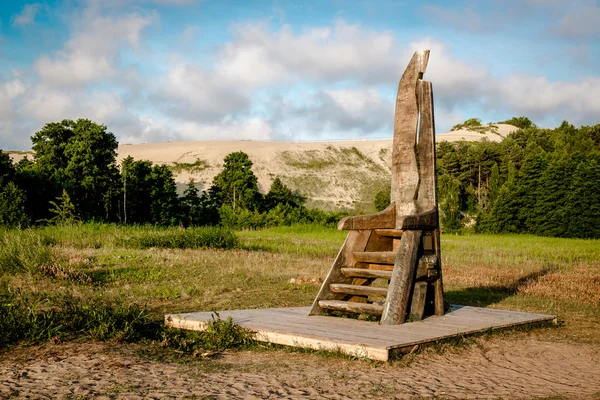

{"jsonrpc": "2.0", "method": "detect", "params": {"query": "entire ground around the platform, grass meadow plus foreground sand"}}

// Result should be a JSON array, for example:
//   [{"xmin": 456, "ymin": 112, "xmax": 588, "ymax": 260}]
[{"xmin": 0, "ymin": 225, "xmax": 600, "ymax": 398}]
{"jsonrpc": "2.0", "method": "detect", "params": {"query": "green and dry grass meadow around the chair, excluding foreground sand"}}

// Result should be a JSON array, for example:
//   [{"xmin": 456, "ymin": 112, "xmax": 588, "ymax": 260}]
[{"xmin": 0, "ymin": 224, "xmax": 600, "ymax": 353}]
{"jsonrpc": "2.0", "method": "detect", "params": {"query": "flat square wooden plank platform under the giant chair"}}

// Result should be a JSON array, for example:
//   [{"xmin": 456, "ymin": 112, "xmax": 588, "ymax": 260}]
[{"xmin": 165, "ymin": 306, "xmax": 556, "ymax": 361}]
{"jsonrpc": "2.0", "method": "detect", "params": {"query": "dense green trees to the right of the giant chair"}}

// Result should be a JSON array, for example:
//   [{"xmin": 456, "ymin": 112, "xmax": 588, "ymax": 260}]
[{"xmin": 436, "ymin": 117, "xmax": 600, "ymax": 238}]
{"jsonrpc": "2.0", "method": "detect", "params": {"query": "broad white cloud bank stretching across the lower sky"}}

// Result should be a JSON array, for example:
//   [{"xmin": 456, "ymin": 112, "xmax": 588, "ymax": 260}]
[{"xmin": 0, "ymin": 0, "xmax": 600, "ymax": 152}]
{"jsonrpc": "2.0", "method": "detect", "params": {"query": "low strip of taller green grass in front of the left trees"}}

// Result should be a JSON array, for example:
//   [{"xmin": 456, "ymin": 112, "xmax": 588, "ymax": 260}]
[{"xmin": 122, "ymin": 227, "xmax": 238, "ymax": 249}]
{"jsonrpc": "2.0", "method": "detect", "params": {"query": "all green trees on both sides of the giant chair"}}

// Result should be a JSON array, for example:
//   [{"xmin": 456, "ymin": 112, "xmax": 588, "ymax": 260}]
[{"xmin": 0, "ymin": 117, "xmax": 600, "ymax": 238}]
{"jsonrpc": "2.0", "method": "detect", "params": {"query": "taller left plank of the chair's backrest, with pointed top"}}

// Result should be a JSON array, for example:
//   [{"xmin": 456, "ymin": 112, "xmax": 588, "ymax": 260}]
[{"xmin": 391, "ymin": 50, "xmax": 429, "ymax": 229}]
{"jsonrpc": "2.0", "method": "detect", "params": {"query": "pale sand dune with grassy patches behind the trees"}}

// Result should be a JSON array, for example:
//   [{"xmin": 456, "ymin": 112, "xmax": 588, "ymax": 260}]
[{"xmin": 3, "ymin": 124, "xmax": 516, "ymax": 211}]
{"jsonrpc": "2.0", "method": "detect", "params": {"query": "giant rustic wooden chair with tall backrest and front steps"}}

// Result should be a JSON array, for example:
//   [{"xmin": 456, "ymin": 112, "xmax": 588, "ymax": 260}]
[{"xmin": 309, "ymin": 50, "xmax": 445, "ymax": 325}]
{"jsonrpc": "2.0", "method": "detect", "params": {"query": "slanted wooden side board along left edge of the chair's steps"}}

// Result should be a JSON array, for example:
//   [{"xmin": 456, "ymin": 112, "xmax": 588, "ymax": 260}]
[{"xmin": 310, "ymin": 230, "xmax": 372, "ymax": 315}]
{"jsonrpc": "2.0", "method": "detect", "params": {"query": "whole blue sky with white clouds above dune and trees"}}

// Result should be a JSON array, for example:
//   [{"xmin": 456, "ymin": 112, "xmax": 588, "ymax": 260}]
[{"xmin": 0, "ymin": 0, "xmax": 600, "ymax": 149}]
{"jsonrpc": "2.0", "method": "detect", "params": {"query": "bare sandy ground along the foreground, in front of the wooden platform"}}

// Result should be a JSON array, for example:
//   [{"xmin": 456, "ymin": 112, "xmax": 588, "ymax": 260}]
[{"xmin": 0, "ymin": 338, "xmax": 600, "ymax": 399}]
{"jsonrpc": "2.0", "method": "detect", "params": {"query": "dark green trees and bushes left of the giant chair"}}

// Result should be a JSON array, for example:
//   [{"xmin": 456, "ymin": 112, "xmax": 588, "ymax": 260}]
[{"xmin": 0, "ymin": 119, "xmax": 342, "ymax": 228}]
